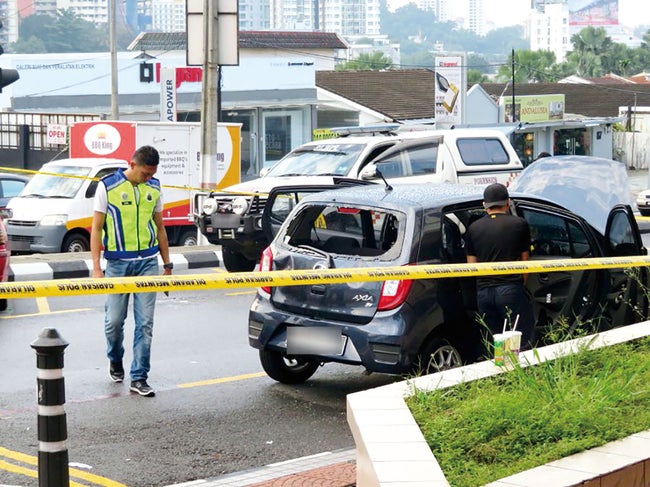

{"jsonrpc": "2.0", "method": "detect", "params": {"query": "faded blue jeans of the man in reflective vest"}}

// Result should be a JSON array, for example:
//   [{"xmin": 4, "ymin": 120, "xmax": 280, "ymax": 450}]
[{"xmin": 104, "ymin": 257, "xmax": 158, "ymax": 381}]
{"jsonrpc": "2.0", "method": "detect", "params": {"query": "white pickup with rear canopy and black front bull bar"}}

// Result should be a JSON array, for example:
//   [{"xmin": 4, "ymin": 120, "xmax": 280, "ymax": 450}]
[{"xmin": 194, "ymin": 126, "xmax": 523, "ymax": 272}]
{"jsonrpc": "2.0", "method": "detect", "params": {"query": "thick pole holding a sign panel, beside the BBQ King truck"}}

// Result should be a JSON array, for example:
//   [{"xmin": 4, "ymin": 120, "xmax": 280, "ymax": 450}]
[{"xmin": 201, "ymin": 0, "xmax": 221, "ymax": 189}]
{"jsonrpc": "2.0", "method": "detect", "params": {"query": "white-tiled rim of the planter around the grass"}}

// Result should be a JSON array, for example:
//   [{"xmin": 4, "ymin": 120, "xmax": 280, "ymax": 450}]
[{"xmin": 347, "ymin": 321, "xmax": 650, "ymax": 487}]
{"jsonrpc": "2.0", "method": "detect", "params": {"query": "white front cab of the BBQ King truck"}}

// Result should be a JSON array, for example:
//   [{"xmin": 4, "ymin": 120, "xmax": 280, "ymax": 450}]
[{"xmin": 7, "ymin": 158, "xmax": 128, "ymax": 253}]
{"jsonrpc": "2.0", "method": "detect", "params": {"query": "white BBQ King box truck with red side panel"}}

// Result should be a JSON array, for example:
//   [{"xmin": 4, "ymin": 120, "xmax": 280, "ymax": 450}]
[{"xmin": 7, "ymin": 122, "xmax": 241, "ymax": 253}]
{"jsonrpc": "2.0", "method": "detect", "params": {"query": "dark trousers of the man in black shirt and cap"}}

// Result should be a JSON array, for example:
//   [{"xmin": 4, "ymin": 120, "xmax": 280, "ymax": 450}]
[{"xmin": 477, "ymin": 283, "xmax": 535, "ymax": 350}]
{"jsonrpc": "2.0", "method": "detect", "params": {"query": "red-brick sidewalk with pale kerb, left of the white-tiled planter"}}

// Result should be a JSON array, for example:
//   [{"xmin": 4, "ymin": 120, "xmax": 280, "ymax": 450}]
[{"xmin": 168, "ymin": 450, "xmax": 356, "ymax": 487}]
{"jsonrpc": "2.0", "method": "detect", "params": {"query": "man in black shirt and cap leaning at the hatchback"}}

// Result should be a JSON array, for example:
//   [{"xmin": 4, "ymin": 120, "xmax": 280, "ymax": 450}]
[{"xmin": 465, "ymin": 183, "xmax": 535, "ymax": 349}]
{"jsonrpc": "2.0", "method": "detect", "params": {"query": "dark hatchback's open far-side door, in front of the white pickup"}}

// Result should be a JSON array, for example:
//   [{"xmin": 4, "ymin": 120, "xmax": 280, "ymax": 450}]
[{"xmin": 262, "ymin": 177, "xmax": 376, "ymax": 242}]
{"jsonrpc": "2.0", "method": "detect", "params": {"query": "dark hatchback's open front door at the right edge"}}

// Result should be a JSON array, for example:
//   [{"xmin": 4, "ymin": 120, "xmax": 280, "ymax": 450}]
[{"xmin": 603, "ymin": 205, "xmax": 648, "ymax": 327}]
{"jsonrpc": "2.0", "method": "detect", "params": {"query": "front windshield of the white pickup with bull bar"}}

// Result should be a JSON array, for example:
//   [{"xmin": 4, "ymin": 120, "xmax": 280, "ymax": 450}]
[{"xmin": 267, "ymin": 143, "xmax": 366, "ymax": 177}]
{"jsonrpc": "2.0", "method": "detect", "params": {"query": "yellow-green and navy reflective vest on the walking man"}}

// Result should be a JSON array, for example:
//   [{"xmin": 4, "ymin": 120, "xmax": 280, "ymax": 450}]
[{"xmin": 101, "ymin": 169, "xmax": 161, "ymax": 259}]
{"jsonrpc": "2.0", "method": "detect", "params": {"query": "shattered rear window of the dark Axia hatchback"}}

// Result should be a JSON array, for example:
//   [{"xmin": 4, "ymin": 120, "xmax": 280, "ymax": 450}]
[{"xmin": 284, "ymin": 205, "xmax": 405, "ymax": 258}]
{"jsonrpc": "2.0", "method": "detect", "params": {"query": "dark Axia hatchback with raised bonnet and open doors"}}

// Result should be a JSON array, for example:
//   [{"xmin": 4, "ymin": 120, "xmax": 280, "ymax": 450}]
[{"xmin": 248, "ymin": 156, "xmax": 648, "ymax": 384}]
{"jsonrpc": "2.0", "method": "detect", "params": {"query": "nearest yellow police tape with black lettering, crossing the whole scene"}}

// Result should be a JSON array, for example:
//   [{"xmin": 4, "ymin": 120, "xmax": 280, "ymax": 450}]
[{"xmin": 0, "ymin": 256, "xmax": 650, "ymax": 298}]
